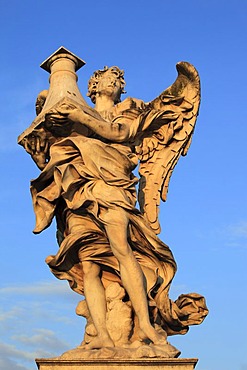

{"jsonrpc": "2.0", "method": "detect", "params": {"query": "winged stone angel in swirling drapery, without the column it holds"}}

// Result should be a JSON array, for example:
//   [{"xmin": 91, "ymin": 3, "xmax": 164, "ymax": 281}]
[{"xmin": 19, "ymin": 53, "xmax": 208, "ymax": 358}]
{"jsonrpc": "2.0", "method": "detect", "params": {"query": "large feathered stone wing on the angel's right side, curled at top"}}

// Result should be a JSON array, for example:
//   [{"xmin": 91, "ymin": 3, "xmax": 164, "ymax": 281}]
[{"xmin": 136, "ymin": 62, "xmax": 200, "ymax": 234}]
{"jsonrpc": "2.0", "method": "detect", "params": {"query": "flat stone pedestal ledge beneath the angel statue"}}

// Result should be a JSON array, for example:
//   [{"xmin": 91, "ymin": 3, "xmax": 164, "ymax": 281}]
[{"xmin": 36, "ymin": 358, "xmax": 198, "ymax": 370}]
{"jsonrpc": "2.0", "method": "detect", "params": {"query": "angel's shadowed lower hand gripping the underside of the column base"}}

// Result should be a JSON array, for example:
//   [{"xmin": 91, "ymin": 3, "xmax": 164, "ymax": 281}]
[{"xmin": 24, "ymin": 130, "xmax": 49, "ymax": 170}]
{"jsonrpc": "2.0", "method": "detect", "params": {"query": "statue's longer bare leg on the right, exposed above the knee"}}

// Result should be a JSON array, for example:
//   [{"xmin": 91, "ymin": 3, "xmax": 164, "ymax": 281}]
[{"xmin": 102, "ymin": 208, "xmax": 166, "ymax": 344}]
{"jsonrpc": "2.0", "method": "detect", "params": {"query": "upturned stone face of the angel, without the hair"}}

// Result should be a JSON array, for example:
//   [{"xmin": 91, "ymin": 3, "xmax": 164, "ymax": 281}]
[{"xmin": 97, "ymin": 70, "xmax": 121, "ymax": 102}]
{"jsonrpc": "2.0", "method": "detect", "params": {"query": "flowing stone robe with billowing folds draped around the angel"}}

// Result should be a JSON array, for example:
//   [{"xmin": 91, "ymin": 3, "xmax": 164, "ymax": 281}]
[{"xmin": 31, "ymin": 99, "xmax": 206, "ymax": 334}]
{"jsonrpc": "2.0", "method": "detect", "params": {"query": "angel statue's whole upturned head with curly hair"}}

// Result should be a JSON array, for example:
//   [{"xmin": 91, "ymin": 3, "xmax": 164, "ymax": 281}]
[{"xmin": 87, "ymin": 66, "xmax": 125, "ymax": 104}]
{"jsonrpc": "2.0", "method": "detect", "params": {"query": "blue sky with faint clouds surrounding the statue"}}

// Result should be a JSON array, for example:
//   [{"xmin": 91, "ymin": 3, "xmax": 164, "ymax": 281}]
[{"xmin": 0, "ymin": 0, "xmax": 247, "ymax": 370}]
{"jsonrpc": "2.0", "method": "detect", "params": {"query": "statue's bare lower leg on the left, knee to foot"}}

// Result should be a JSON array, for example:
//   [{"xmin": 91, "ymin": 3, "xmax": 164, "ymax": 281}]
[{"xmin": 81, "ymin": 261, "xmax": 114, "ymax": 349}]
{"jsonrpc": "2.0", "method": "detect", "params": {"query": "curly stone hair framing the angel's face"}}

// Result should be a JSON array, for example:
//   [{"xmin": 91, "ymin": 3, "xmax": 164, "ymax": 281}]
[{"xmin": 87, "ymin": 66, "xmax": 126, "ymax": 104}]
